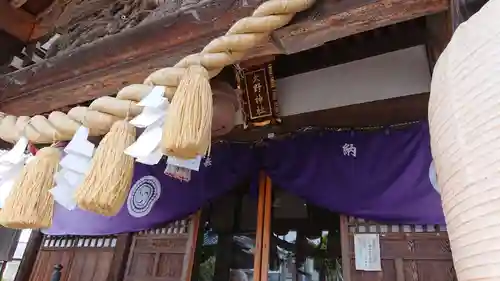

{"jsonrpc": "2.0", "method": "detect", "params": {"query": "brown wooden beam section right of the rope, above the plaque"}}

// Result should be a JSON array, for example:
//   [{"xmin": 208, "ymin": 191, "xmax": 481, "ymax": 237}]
[{"xmin": 273, "ymin": 0, "xmax": 449, "ymax": 54}]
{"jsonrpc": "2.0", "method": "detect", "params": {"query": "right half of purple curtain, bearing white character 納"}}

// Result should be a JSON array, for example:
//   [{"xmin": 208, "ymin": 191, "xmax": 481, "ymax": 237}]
[{"xmin": 263, "ymin": 123, "xmax": 444, "ymax": 224}]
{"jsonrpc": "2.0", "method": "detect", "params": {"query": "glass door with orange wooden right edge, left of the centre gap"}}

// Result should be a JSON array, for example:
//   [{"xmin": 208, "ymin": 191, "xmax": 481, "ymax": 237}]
[{"xmin": 191, "ymin": 177, "xmax": 263, "ymax": 281}]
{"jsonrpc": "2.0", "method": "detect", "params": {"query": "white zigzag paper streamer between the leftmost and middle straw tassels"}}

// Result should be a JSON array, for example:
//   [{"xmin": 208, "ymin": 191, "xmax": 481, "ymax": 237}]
[{"xmin": 50, "ymin": 126, "xmax": 95, "ymax": 210}]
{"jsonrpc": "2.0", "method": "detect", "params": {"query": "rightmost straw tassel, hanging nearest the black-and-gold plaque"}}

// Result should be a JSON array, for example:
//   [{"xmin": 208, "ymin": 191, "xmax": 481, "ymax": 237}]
[{"xmin": 162, "ymin": 65, "xmax": 213, "ymax": 159}]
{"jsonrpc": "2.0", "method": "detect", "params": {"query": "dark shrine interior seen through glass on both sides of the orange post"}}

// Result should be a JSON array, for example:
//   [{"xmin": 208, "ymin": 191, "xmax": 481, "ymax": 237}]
[{"xmin": 192, "ymin": 185, "xmax": 341, "ymax": 281}]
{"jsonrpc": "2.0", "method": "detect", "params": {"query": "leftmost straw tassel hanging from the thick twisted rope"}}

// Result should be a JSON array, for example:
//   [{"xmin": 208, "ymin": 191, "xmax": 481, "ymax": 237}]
[{"xmin": 0, "ymin": 147, "xmax": 61, "ymax": 229}]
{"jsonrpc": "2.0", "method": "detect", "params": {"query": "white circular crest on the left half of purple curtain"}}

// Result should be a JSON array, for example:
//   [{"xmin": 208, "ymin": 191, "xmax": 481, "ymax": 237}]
[{"xmin": 127, "ymin": 176, "xmax": 161, "ymax": 218}]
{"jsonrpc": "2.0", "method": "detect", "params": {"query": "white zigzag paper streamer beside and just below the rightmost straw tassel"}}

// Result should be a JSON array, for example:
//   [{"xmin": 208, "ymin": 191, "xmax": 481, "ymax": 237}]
[{"xmin": 125, "ymin": 86, "xmax": 201, "ymax": 181}]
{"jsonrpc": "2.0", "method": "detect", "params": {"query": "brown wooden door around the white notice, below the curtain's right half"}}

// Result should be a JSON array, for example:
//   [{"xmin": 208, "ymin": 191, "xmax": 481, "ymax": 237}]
[{"xmin": 341, "ymin": 216, "xmax": 456, "ymax": 281}]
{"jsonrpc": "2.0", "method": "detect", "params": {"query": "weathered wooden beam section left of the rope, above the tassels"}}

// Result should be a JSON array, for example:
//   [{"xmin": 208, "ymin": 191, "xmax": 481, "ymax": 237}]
[{"xmin": 0, "ymin": 0, "xmax": 262, "ymax": 115}]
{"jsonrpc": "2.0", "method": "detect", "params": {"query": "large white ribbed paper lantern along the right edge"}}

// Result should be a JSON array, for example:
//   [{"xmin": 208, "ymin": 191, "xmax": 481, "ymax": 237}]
[{"xmin": 429, "ymin": 0, "xmax": 500, "ymax": 281}]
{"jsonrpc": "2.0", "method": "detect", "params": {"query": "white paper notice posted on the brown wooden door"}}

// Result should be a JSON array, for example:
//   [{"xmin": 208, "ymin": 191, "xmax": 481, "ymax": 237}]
[{"xmin": 354, "ymin": 234, "xmax": 382, "ymax": 271}]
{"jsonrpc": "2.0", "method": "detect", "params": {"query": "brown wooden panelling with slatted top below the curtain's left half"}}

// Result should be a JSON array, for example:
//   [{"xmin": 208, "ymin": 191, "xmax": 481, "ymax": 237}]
[{"xmin": 22, "ymin": 214, "xmax": 200, "ymax": 281}]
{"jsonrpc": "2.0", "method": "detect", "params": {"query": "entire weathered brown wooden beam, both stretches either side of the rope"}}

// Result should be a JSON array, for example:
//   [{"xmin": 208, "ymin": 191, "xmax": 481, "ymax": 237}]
[{"xmin": 0, "ymin": 0, "xmax": 448, "ymax": 115}]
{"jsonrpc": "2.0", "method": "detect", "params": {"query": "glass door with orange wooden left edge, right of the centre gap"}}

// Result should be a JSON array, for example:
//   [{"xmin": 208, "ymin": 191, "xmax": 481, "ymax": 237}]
[{"xmin": 260, "ymin": 179, "xmax": 343, "ymax": 281}]
